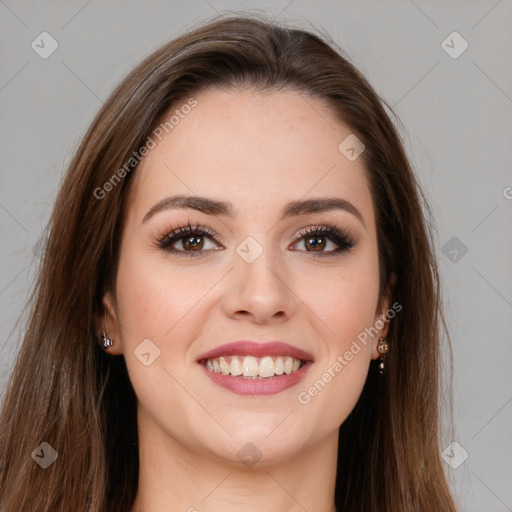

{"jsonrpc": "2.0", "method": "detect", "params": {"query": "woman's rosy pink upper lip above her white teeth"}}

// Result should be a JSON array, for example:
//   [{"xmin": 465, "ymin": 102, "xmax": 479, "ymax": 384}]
[{"xmin": 198, "ymin": 340, "xmax": 313, "ymax": 361}]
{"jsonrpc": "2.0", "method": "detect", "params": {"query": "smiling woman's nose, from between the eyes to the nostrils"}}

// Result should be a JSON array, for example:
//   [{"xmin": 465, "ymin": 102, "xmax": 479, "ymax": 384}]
[{"xmin": 223, "ymin": 243, "xmax": 297, "ymax": 324}]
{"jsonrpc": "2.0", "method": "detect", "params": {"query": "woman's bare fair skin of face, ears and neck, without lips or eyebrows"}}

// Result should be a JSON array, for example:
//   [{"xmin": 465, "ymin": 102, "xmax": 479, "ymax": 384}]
[{"xmin": 101, "ymin": 90, "xmax": 389, "ymax": 512}]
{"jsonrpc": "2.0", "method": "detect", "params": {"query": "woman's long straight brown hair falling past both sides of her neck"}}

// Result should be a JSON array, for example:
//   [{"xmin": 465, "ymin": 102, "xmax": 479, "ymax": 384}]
[{"xmin": 0, "ymin": 16, "xmax": 456, "ymax": 512}]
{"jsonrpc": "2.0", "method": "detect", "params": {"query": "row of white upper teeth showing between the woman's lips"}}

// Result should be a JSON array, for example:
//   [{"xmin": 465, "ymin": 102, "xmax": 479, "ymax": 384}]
[{"xmin": 206, "ymin": 356, "xmax": 302, "ymax": 379}]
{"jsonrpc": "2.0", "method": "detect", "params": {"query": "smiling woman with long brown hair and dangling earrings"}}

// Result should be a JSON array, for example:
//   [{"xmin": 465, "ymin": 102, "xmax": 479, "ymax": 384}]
[{"xmin": 0, "ymin": 13, "xmax": 456, "ymax": 512}]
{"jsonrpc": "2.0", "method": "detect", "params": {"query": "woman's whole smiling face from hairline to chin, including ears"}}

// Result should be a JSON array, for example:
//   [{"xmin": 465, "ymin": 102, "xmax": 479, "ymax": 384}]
[{"xmin": 104, "ymin": 90, "xmax": 388, "ymax": 464}]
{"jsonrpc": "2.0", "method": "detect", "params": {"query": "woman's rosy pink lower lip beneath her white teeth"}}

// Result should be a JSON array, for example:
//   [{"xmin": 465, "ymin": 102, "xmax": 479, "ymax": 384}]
[{"xmin": 200, "ymin": 361, "xmax": 312, "ymax": 396}]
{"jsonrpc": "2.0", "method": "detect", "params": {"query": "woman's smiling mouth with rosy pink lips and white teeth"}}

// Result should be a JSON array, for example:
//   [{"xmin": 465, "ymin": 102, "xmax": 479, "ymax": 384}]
[{"xmin": 197, "ymin": 341, "xmax": 313, "ymax": 395}]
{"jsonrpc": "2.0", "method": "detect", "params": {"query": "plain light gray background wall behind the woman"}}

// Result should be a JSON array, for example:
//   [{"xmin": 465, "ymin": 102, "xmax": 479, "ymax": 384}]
[{"xmin": 0, "ymin": 0, "xmax": 512, "ymax": 512}]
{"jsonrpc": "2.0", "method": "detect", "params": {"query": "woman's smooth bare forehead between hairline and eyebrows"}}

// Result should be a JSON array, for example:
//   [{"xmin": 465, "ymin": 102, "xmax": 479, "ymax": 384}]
[{"xmin": 123, "ymin": 90, "xmax": 373, "ymax": 227}]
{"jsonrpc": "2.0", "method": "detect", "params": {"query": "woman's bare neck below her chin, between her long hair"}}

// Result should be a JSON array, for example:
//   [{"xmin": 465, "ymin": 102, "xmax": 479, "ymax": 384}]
[{"xmin": 131, "ymin": 410, "xmax": 338, "ymax": 512}]
